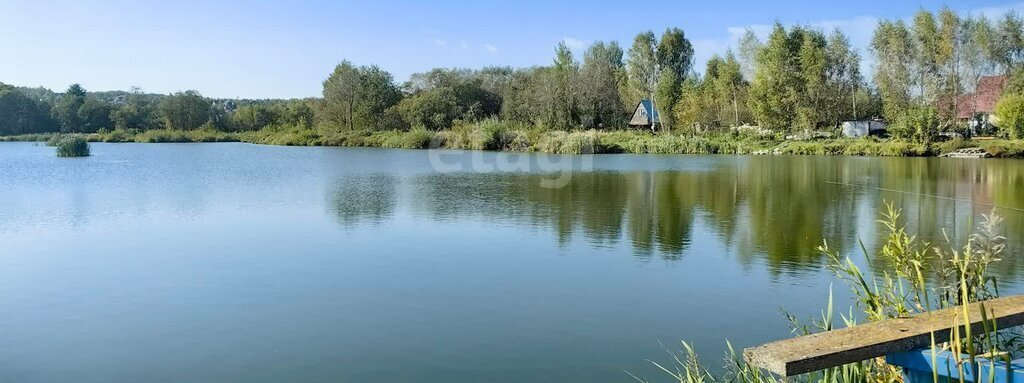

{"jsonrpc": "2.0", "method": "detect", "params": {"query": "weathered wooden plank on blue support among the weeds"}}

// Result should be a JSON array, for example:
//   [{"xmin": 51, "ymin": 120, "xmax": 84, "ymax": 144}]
[{"xmin": 743, "ymin": 295, "xmax": 1024, "ymax": 377}]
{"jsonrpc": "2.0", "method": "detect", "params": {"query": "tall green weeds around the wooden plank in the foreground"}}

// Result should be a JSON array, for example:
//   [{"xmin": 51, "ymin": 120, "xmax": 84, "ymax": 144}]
[{"xmin": 634, "ymin": 205, "xmax": 1011, "ymax": 383}]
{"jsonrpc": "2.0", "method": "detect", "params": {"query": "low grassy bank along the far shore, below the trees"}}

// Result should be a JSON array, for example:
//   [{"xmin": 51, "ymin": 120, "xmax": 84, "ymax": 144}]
[{"xmin": 8, "ymin": 120, "xmax": 1024, "ymax": 158}]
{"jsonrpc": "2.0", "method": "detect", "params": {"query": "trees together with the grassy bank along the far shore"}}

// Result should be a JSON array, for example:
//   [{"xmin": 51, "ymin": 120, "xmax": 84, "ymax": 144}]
[{"xmin": 0, "ymin": 8, "xmax": 1024, "ymax": 157}]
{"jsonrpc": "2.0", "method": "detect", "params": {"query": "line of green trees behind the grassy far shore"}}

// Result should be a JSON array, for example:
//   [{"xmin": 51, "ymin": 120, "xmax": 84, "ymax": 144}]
[{"xmin": 6, "ymin": 8, "xmax": 1024, "ymax": 140}]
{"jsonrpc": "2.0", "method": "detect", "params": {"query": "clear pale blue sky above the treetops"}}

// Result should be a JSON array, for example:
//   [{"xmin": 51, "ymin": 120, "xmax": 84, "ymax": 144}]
[{"xmin": 0, "ymin": 0, "xmax": 1024, "ymax": 98}]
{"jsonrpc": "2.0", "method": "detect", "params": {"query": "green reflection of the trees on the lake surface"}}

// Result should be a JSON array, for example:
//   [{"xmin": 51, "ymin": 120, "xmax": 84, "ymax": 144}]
[{"xmin": 331, "ymin": 157, "xmax": 1024, "ymax": 275}]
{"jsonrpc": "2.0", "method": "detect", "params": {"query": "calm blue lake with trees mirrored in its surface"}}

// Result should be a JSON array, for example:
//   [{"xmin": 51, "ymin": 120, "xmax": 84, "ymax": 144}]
[{"xmin": 0, "ymin": 142, "xmax": 1024, "ymax": 383}]
